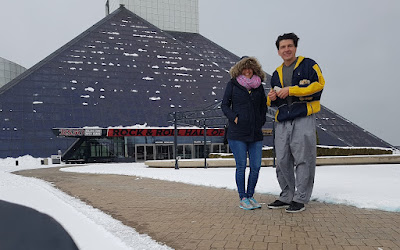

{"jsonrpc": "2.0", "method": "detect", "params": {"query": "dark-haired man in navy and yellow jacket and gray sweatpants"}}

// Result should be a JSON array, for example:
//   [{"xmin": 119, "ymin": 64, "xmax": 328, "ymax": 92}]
[{"xmin": 267, "ymin": 33, "xmax": 325, "ymax": 213}]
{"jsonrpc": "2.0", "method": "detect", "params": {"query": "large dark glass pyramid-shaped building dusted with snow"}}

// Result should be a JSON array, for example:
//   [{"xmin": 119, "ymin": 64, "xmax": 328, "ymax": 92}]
[{"xmin": 0, "ymin": 3, "xmax": 392, "ymax": 161}]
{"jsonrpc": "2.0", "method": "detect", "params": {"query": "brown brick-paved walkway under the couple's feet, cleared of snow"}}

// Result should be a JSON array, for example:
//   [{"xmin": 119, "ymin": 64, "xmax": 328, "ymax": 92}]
[{"xmin": 18, "ymin": 168, "xmax": 400, "ymax": 250}]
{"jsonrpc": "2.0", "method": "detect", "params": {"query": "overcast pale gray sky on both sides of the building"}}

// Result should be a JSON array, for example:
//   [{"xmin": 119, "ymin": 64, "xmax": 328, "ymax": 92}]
[{"xmin": 0, "ymin": 0, "xmax": 400, "ymax": 145}]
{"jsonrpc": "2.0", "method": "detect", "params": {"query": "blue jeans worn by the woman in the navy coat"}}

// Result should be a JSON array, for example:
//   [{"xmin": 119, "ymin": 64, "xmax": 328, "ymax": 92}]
[{"xmin": 228, "ymin": 140, "xmax": 263, "ymax": 199}]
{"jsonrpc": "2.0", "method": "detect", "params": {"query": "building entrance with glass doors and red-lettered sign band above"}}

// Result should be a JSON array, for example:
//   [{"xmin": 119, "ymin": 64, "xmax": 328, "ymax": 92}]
[{"xmin": 53, "ymin": 128, "xmax": 228, "ymax": 163}]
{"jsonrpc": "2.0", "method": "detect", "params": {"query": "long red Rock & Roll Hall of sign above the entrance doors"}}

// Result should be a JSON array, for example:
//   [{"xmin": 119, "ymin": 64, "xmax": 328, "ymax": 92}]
[{"xmin": 107, "ymin": 128, "xmax": 225, "ymax": 137}]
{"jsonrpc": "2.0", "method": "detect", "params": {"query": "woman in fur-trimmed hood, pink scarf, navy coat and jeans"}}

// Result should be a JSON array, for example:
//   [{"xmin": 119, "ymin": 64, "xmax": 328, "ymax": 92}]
[{"xmin": 221, "ymin": 57, "xmax": 267, "ymax": 210}]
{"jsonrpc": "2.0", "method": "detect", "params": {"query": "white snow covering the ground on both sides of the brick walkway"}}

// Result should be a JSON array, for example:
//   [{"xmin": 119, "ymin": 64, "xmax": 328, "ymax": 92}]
[{"xmin": 0, "ymin": 156, "xmax": 400, "ymax": 249}]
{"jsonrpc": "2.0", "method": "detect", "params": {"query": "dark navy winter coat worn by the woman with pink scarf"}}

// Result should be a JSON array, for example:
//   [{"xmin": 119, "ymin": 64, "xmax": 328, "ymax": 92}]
[{"xmin": 221, "ymin": 78, "xmax": 267, "ymax": 142}]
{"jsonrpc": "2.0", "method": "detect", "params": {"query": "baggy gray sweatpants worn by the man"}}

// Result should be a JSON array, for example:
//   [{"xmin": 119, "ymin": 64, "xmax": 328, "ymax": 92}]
[{"xmin": 275, "ymin": 115, "xmax": 317, "ymax": 203}]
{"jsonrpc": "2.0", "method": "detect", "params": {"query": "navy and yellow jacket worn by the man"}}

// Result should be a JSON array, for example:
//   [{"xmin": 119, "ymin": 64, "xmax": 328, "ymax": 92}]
[{"xmin": 267, "ymin": 56, "xmax": 325, "ymax": 122}]
